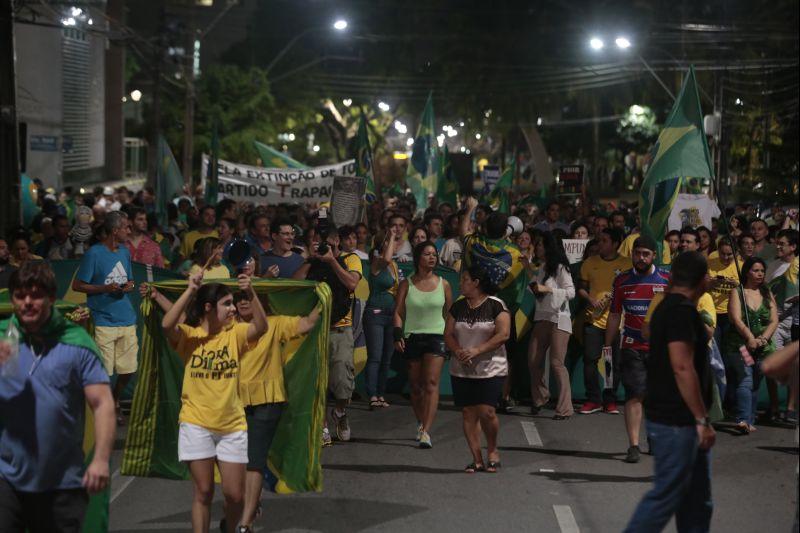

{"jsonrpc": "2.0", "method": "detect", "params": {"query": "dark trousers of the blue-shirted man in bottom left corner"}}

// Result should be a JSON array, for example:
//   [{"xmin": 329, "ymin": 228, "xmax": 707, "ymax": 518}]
[{"xmin": 0, "ymin": 477, "xmax": 89, "ymax": 533}]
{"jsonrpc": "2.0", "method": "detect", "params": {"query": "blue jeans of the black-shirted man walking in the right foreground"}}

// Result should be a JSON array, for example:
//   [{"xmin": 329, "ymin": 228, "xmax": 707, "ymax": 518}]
[{"xmin": 625, "ymin": 420, "xmax": 713, "ymax": 533}]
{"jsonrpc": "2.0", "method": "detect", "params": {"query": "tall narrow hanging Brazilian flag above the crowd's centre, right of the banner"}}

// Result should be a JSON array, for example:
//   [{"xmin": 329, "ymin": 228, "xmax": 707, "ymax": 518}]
[{"xmin": 406, "ymin": 94, "xmax": 439, "ymax": 211}]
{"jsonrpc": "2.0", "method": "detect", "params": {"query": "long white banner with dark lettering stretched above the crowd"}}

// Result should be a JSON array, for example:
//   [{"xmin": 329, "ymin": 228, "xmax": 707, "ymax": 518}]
[{"xmin": 201, "ymin": 154, "xmax": 356, "ymax": 204}]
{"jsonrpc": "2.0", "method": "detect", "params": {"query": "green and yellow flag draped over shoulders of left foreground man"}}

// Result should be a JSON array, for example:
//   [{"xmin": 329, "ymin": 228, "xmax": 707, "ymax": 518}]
[{"xmin": 0, "ymin": 306, "xmax": 111, "ymax": 533}]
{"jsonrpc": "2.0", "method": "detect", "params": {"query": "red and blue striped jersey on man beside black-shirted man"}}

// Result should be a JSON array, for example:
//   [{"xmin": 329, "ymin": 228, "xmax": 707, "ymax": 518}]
[{"xmin": 610, "ymin": 267, "xmax": 669, "ymax": 351}]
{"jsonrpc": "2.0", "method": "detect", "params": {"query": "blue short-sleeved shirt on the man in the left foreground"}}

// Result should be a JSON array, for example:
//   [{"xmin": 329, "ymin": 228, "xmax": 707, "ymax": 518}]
[{"xmin": 0, "ymin": 341, "xmax": 109, "ymax": 492}]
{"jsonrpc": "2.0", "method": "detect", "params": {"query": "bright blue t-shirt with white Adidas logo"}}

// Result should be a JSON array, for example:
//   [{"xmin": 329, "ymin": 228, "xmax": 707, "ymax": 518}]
[{"xmin": 76, "ymin": 243, "xmax": 136, "ymax": 327}]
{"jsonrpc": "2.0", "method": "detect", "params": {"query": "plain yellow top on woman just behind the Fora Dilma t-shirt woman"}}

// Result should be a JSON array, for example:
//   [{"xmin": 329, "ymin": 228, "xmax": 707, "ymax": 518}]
[{"xmin": 239, "ymin": 316, "xmax": 301, "ymax": 406}]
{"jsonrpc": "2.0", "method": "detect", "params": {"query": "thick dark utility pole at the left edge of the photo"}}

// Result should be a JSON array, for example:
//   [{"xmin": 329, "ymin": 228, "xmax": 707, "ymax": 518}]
[{"xmin": 0, "ymin": 0, "xmax": 22, "ymax": 236}]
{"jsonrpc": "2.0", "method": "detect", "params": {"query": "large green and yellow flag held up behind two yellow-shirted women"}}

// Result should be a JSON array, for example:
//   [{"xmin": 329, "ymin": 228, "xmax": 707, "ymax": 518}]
[{"xmin": 121, "ymin": 279, "xmax": 331, "ymax": 493}]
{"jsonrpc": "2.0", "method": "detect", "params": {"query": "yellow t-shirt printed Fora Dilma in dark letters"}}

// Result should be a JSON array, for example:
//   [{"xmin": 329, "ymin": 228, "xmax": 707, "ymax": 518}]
[{"xmin": 176, "ymin": 323, "xmax": 249, "ymax": 433}]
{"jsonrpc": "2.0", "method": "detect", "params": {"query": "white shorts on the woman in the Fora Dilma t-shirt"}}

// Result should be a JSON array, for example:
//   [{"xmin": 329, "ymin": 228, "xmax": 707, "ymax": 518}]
[{"xmin": 178, "ymin": 422, "xmax": 247, "ymax": 463}]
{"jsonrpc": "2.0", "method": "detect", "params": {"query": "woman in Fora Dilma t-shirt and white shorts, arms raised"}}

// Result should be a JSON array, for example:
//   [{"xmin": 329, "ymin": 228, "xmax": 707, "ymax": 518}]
[{"xmin": 161, "ymin": 271, "xmax": 267, "ymax": 533}]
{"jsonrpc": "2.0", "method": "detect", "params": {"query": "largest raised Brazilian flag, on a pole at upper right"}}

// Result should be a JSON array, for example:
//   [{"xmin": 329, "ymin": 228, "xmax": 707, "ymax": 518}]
[{"xmin": 639, "ymin": 66, "xmax": 714, "ymax": 264}]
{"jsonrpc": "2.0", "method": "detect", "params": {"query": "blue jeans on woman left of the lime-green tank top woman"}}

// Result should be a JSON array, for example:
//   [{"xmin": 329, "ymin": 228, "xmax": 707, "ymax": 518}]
[{"xmin": 364, "ymin": 307, "xmax": 394, "ymax": 397}]
